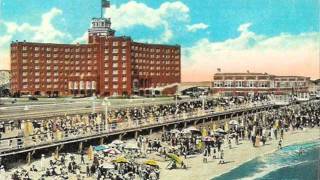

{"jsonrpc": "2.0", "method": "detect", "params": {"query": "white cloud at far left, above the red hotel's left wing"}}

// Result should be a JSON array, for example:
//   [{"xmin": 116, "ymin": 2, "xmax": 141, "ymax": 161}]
[{"xmin": 0, "ymin": 7, "xmax": 71, "ymax": 69}]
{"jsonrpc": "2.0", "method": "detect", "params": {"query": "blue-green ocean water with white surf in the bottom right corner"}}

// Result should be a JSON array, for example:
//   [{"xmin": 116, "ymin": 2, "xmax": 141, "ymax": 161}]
[{"xmin": 213, "ymin": 141, "xmax": 320, "ymax": 180}]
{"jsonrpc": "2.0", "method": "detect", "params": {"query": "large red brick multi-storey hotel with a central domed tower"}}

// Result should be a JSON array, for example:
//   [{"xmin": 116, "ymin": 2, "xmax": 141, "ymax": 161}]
[{"xmin": 11, "ymin": 12, "xmax": 181, "ymax": 96}]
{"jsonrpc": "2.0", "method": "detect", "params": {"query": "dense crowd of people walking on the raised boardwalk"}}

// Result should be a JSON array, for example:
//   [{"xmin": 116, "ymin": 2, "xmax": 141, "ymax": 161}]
[{"xmin": 0, "ymin": 96, "xmax": 266, "ymax": 148}]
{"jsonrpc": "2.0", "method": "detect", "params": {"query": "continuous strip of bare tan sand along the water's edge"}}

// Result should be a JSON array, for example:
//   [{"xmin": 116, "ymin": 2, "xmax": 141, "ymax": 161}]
[{"xmin": 159, "ymin": 127, "xmax": 320, "ymax": 180}]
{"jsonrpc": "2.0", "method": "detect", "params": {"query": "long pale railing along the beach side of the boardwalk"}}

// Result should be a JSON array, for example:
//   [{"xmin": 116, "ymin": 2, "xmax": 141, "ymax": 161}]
[{"xmin": 0, "ymin": 102, "xmax": 273, "ymax": 156}]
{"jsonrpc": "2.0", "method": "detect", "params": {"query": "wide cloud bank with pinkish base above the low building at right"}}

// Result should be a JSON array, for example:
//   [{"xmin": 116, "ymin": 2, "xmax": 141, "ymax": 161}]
[{"xmin": 182, "ymin": 23, "xmax": 320, "ymax": 81}]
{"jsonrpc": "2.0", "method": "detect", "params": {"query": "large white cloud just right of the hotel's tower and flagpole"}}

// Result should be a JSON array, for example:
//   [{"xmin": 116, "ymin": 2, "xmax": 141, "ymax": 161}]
[{"xmin": 105, "ymin": 1, "xmax": 189, "ymax": 43}]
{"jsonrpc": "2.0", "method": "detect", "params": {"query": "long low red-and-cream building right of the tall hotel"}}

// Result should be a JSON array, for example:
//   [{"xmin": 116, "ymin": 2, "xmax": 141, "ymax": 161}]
[{"xmin": 212, "ymin": 72, "xmax": 310, "ymax": 96}]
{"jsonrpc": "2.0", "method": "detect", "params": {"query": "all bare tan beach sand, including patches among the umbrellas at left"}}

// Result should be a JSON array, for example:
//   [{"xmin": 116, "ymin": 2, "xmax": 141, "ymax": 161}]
[{"xmin": 0, "ymin": 128, "xmax": 320, "ymax": 180}]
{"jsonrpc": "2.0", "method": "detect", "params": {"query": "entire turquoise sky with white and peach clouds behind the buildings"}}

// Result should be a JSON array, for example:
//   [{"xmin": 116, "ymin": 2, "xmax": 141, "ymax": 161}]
[{"xmin": 0, "ymin": 0, "xmax": 320, "ymax": 81}]
